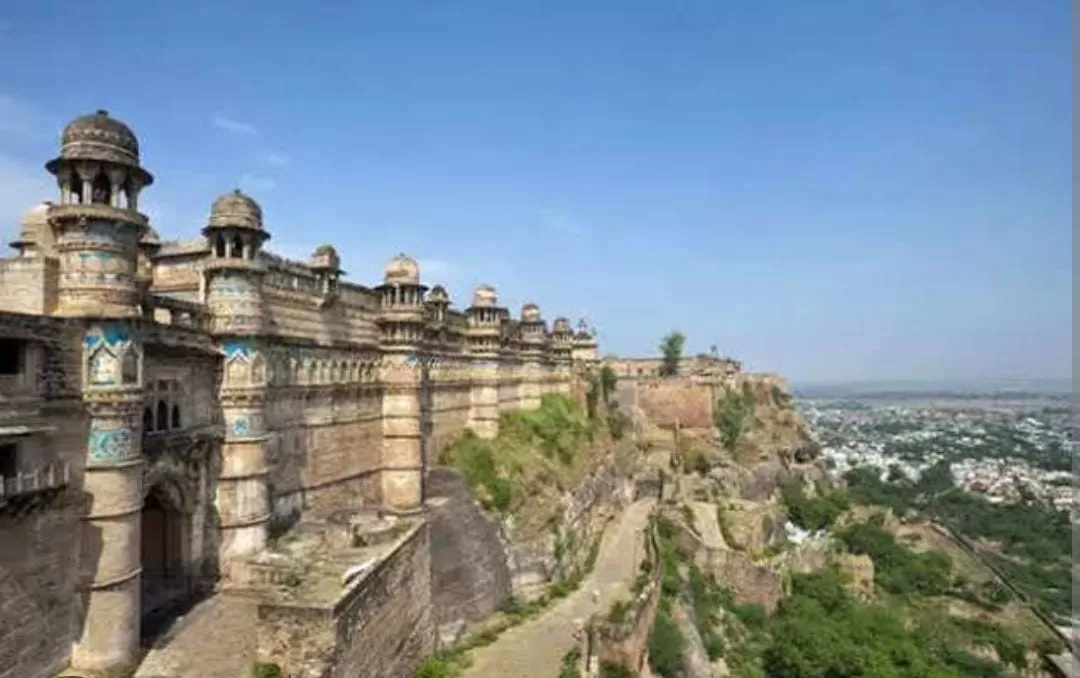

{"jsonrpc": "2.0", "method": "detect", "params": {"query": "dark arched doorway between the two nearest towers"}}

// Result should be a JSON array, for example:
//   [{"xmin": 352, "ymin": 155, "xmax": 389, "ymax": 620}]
[{"xmin": 141, "ymin": 486, "xmax": 190, "ymax": 636}]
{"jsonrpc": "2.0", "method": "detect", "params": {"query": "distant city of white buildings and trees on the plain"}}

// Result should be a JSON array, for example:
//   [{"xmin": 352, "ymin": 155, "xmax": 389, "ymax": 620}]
[{"xmin": 799, "ymin": 388, "xmax": 1074, "ymax": 511}]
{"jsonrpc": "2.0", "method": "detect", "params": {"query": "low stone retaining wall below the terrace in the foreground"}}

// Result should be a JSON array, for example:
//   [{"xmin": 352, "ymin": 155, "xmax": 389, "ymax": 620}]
[{"xmin": 256, "ymin": 524, "xmax": 435, "ymax": 678}]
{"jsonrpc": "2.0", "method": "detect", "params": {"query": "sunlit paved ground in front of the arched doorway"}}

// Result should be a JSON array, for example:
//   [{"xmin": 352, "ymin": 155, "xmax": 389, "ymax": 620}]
[{"xmin": 135, "ymin": 594, "xmax": 256, "ymax": 678}]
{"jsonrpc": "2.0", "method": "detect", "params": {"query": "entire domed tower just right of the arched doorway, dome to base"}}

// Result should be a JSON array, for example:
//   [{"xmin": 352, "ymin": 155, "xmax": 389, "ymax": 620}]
[{"xmin": 203, "ymin": 190, "xmax": 270, "ymax": 565}]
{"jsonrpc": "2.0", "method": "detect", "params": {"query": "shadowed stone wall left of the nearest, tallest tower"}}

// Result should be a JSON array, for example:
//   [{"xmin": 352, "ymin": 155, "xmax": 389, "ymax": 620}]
[{"xmin": 0, "ymin": 328, "xmax": 85, "ymax": 678}]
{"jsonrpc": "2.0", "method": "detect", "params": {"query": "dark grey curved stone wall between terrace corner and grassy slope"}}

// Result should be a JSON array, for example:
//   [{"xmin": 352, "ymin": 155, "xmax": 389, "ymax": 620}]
[{"xmin": 428, "ymin": 466, "xmax": 512, "ymax": 639}]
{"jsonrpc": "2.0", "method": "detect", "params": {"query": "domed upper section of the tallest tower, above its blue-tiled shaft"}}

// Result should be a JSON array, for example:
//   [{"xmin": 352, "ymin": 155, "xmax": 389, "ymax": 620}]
[{"xmin": 45, "ymin": 110, "xmax": 153, "ymax": 317}]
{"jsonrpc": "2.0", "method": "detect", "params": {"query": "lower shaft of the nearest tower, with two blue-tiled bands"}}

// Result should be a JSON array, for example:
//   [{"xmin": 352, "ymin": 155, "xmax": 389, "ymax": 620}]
[{"xmin": 71, "ymin": 323, "xmax": 143, "ymax": 675}]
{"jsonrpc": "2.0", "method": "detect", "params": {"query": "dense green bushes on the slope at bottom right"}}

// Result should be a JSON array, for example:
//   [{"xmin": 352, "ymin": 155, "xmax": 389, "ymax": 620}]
[{"xmin": 649, "ymin": 498, "xmax": 1057, "ymax": 678}]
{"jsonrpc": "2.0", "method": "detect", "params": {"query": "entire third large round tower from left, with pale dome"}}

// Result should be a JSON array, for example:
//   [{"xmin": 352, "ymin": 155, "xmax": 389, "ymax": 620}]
[{"xmin": 375, "ymin": 254, "xmax": 429, "ymax": 512}]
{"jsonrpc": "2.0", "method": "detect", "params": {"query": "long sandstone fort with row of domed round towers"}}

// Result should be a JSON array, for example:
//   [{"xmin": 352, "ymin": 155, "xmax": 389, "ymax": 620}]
[{"xmin": 0, "ymin": 111, "xmax": 600, "ymax": 678}]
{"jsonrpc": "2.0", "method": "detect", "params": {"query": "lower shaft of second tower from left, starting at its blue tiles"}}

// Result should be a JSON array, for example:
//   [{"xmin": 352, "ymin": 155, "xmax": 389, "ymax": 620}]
[{"xmin": 217, "ymin": 338, "xmax": 270, "ymax": 565}]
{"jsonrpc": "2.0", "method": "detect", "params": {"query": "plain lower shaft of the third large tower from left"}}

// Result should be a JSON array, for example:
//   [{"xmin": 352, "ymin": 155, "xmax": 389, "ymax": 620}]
[{"xmin": 380, "ymin": 353, "xmax": 424, "ymax": 512}]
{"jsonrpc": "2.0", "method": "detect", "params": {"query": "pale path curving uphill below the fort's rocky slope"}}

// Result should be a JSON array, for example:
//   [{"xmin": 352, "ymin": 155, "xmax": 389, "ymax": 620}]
[{"xmin": 463, "ymin": 499, "xmax": 653, "ymax": 678}]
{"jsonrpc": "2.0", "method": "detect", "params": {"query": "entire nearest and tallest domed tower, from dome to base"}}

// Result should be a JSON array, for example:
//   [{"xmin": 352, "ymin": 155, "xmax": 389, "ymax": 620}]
[{"xmin": 39, "ymin": 110, "xmax": 153, "ymax": 670}]
